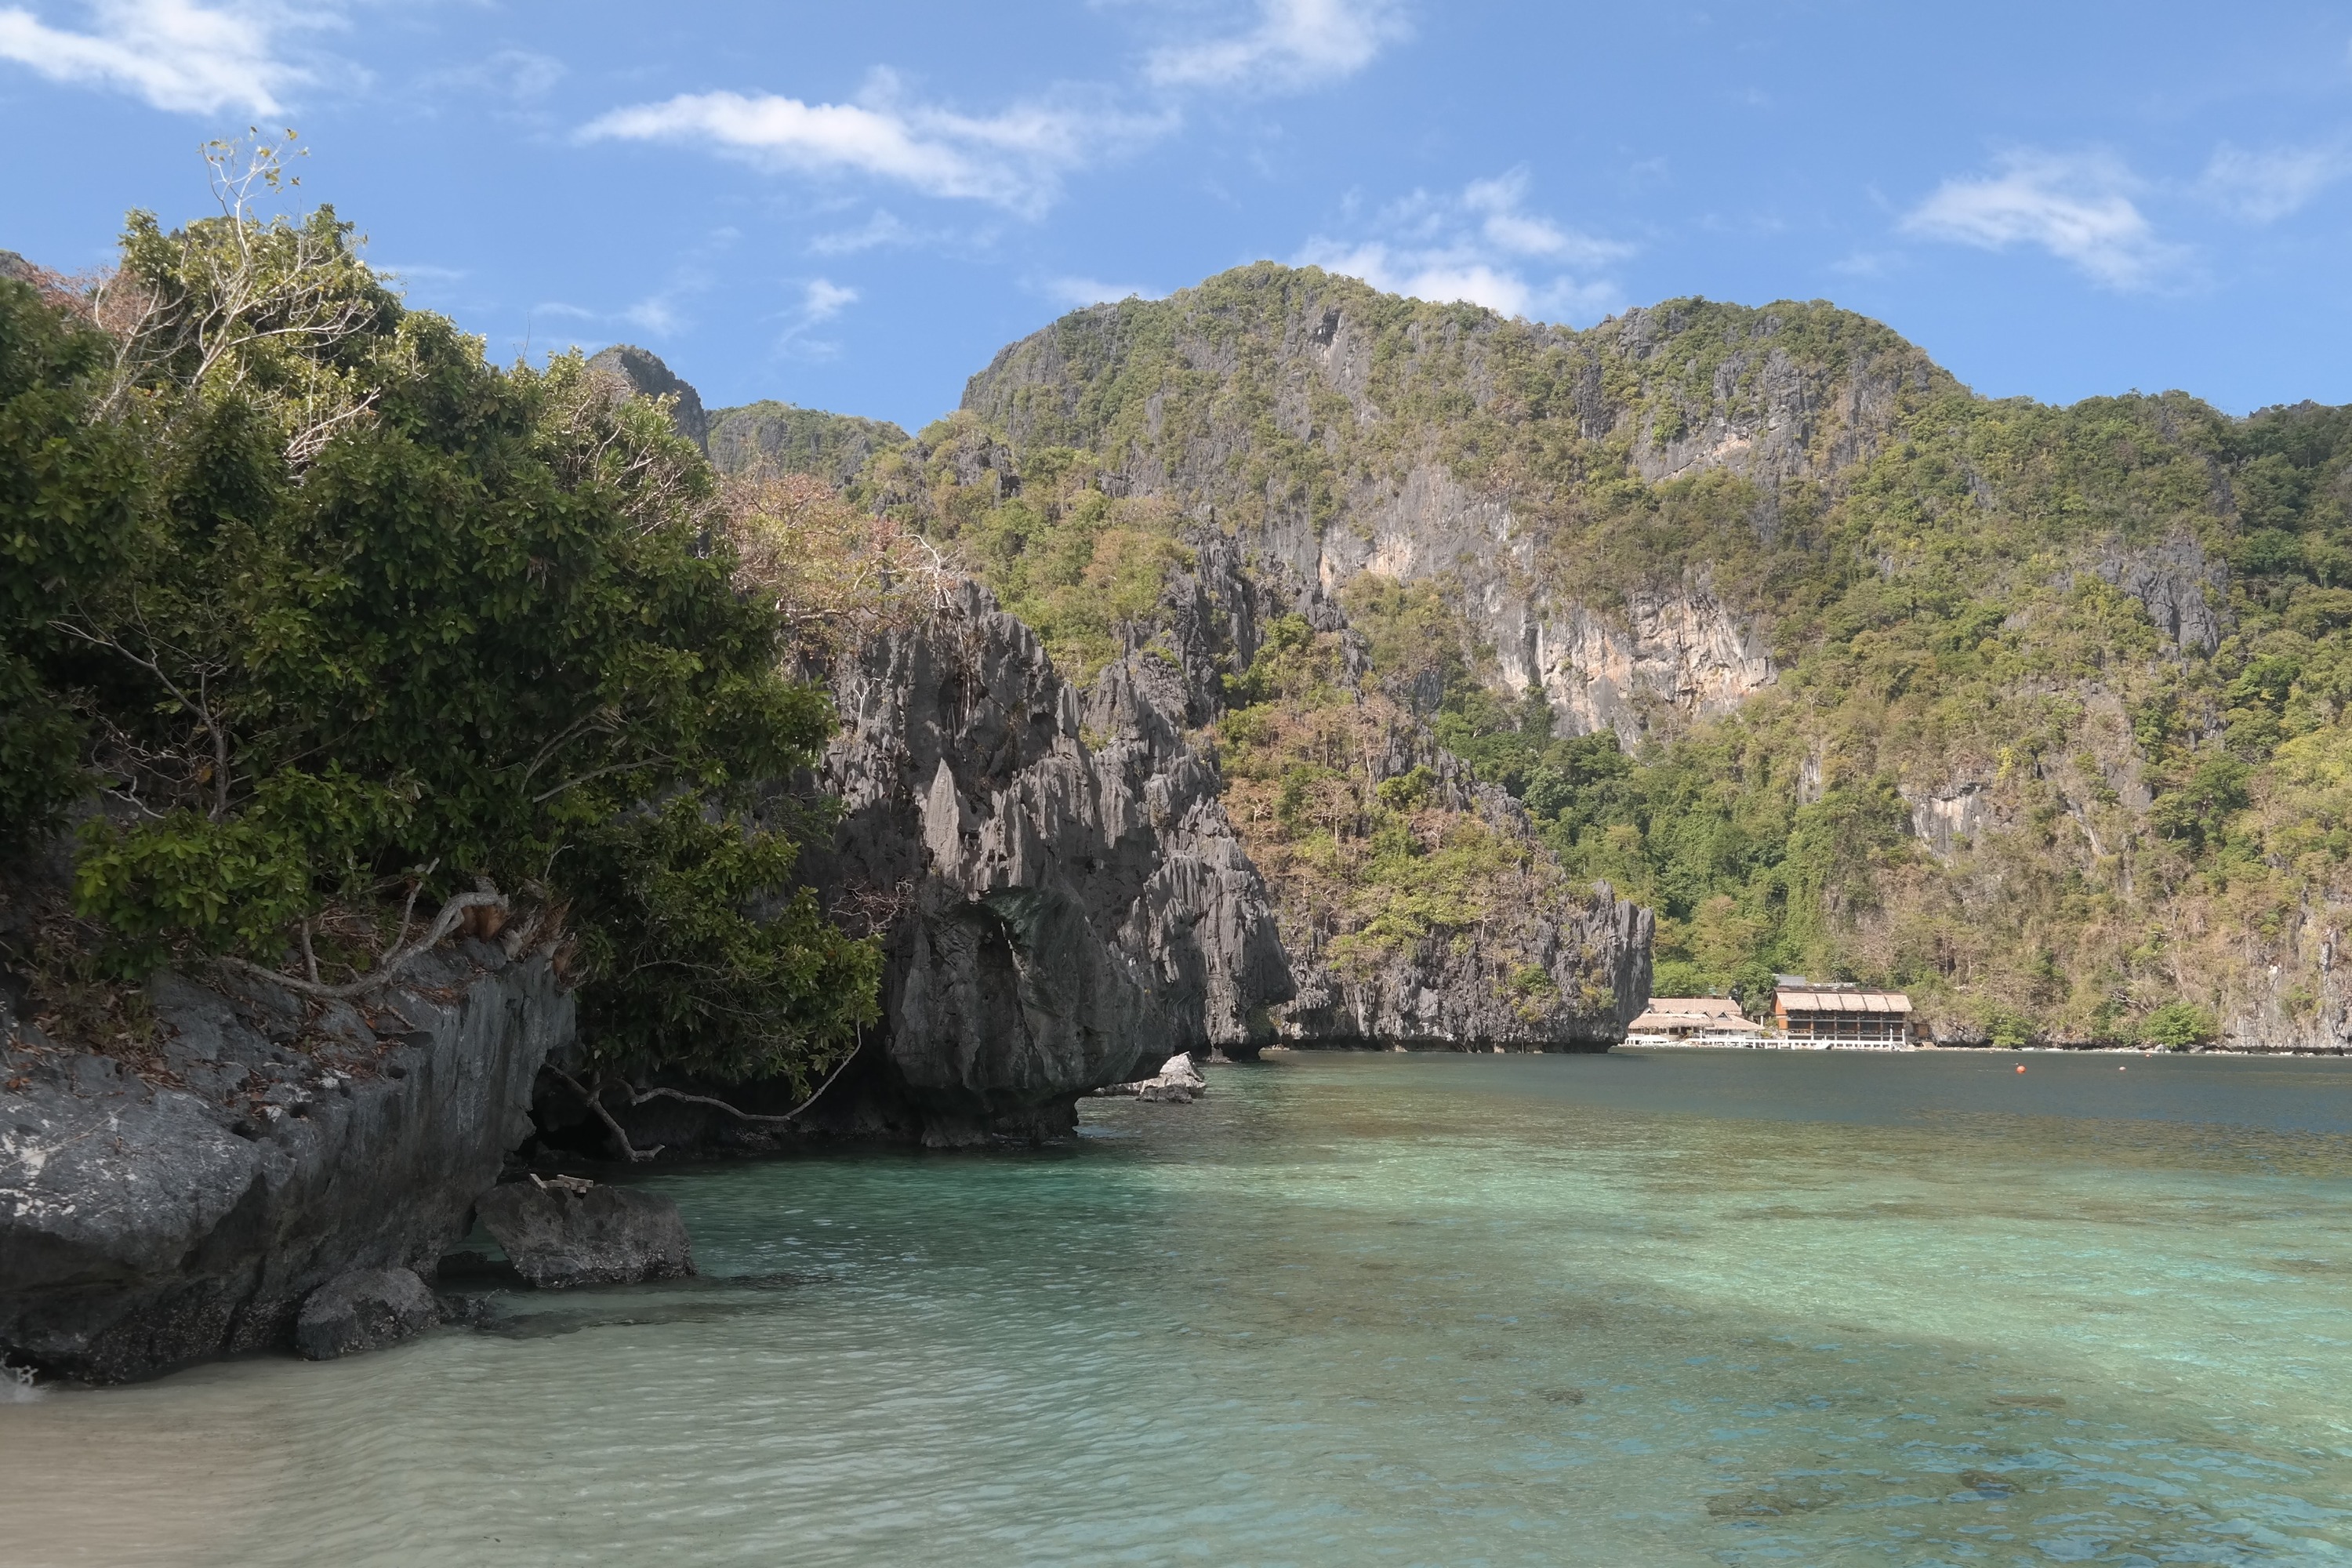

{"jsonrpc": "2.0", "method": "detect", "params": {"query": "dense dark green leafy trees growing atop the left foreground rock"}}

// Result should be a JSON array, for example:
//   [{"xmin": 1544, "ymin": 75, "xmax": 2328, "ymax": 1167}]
[{"xmin": 0, "ymin": 147, "xmax": 880, "ymax": 1074}]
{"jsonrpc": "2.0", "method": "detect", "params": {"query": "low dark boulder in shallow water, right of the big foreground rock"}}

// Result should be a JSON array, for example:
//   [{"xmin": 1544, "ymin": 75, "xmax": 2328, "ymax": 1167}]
[{"xmin": 475, "ymin": 1180, "xmax": 694, "ymax": 1290}]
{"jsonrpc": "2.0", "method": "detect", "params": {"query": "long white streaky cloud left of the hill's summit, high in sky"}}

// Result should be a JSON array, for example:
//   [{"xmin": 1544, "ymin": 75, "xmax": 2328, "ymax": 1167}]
[{"xmin": 581, "ymin": 71, "xmax": 1171, "ymax": 212}]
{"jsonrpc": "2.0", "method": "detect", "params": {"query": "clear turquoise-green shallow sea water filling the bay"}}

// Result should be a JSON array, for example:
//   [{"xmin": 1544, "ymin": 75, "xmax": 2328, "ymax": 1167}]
[{"xmin": 0, "ymin": 1053, "xmax": 2352, "ymax": 1566}]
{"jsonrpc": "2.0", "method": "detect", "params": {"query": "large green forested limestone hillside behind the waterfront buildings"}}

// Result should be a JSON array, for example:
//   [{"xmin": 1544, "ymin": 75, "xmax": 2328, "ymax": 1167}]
[{"xmin": 818, "ymin": 266, "xmax": 2352, "ymax": 1044}]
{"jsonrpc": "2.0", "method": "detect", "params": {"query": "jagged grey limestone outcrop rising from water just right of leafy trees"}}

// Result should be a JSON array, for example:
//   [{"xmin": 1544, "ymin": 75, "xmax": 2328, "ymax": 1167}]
[{"xmin": 567, "ymin": 583, "xmax": 1294, "ymax": 1154}]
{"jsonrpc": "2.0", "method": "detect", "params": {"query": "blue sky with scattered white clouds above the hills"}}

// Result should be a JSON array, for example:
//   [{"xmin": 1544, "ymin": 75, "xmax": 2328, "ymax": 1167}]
[{"xmin": 0, "ymin": 0, "xmax": 2352, "ymax": 428}]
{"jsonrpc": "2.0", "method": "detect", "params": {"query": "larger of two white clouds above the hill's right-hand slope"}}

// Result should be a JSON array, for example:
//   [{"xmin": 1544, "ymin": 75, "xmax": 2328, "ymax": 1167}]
[{"xmin": 1903, "ymin": 153, "xmax": 2178, "ymax": 289}]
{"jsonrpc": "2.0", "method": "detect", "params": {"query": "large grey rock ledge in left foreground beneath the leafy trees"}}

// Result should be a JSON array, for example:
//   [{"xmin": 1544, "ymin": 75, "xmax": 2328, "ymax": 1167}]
[{"xmin": 0, "ymin": 942, "xmax": 574, "ymax": 1382}]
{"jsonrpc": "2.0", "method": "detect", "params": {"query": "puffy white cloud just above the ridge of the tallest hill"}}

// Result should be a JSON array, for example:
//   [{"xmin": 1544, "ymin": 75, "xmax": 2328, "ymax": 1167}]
[{"xmin": 1298, "ymin": 169, "xmax": 1632, "ymax": 320}]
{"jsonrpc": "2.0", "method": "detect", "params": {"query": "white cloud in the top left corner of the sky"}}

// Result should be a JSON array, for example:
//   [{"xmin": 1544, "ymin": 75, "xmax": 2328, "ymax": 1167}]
[{"xmin": 0, "ymin": 0, "xmax": 315, "ymax": 115}]
